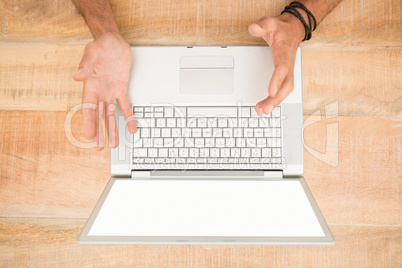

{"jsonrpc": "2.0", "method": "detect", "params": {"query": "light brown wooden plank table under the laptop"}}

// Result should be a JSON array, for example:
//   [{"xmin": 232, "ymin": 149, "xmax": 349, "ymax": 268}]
[{"xmin": 0, "ymin": 0, "xmax": 402, "ymax": 267}]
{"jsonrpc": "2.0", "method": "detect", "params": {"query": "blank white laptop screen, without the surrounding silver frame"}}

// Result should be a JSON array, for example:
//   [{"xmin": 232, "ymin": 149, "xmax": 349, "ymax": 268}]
[{"xmin": 88, "ymin": 179, "xmax": 324, "ymax": 237}]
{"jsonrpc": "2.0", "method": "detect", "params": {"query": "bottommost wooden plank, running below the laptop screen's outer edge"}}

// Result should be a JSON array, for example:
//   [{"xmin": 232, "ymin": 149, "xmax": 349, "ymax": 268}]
[{"xmin": 0, "ymin": 218, "xmax": 402, "ymax": 267}]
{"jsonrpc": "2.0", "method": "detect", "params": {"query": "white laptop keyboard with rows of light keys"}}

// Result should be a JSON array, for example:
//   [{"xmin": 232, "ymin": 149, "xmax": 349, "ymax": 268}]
[{"xmin": 132, "ymin": 106, "xmax": 282, "ymax": 170}]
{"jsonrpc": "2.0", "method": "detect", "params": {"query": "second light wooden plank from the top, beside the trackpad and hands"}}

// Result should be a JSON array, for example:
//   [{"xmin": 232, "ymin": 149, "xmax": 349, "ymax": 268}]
[{"xmin": 0, "ymin": 43, "xmax": 402, "ymax": 118}]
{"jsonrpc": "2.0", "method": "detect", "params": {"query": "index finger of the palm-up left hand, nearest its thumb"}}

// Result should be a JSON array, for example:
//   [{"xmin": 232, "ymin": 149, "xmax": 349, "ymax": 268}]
[{"xmin": 82, "ymin": 81, "xmax": 98, "ymax": 139}]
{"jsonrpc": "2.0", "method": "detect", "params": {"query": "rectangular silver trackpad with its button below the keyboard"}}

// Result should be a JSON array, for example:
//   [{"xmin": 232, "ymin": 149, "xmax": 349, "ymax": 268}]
[{"xmin": 180, "ymin": 56, "xmax": 234, "ymax": 94}]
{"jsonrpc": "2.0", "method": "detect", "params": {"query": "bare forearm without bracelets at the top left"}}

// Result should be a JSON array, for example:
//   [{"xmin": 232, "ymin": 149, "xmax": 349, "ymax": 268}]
[{"xmin": 72, "ymin": 0, "xmax": 119, "ymax": 39}]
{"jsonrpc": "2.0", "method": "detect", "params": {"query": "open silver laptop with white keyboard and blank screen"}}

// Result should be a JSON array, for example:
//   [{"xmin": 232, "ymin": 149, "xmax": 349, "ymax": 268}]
[{"xmin": 78, "ymin": 46, "xmax": 334, "ymax": 245}]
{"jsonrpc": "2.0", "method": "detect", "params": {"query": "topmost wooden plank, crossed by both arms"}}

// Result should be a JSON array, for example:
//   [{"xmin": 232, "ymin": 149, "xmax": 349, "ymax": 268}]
[{"xmin": 0, "ymin": 0, "xmax": 402, "ymax": 47}]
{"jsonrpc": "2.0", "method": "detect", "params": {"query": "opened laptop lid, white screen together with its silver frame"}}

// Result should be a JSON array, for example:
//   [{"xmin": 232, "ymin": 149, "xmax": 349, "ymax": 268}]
[{"xmin": 79, "ymin": 176, "xmax": 334, "ymax": 245}]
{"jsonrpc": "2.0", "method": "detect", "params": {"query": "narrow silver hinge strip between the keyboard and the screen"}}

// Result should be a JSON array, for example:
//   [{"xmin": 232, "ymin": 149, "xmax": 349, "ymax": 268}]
[{"xmin": 131, "ymin": 170, "xmax": 283, "ymax": 179}]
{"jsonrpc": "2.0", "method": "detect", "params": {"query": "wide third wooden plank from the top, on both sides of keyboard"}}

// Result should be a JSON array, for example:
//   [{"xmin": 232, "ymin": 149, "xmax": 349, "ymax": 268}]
[{"xmin": 0, "ymin": 111, "xmax": 402, "ymax": 224}]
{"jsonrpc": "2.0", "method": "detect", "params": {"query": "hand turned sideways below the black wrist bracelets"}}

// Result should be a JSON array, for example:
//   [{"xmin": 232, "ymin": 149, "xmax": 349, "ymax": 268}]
[{"xmin": 248, "ymin": 13, "xmax": 304, "ymax": 115}]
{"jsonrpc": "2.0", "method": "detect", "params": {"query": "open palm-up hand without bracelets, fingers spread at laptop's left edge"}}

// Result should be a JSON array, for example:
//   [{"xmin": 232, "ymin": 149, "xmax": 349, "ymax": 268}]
[{"xmin": 74, "ymin": 32, "xmax": 137, "ymax": 150}]
